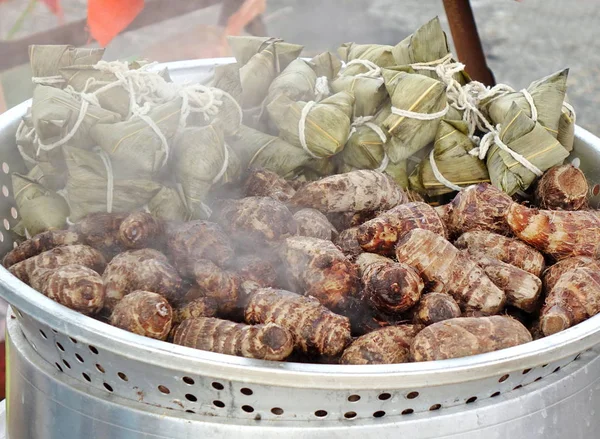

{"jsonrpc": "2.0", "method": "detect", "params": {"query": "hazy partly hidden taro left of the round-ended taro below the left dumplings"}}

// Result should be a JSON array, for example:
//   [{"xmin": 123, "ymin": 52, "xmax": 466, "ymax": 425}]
[{"xmin": 72, "ymin": 213, "xmax": 127, "ymax": 261}]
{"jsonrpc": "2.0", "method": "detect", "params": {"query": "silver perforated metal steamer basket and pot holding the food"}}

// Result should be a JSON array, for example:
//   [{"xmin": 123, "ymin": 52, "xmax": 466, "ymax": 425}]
[{"xmin": 0, "ymin": 60, "xmax": 600, "ymax": 439}]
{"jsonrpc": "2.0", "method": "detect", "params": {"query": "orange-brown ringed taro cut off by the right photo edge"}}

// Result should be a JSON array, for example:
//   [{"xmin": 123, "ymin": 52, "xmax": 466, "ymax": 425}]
[{"xmin": 507, "ymin": 203, "xmax": 600, "ymax": 260}]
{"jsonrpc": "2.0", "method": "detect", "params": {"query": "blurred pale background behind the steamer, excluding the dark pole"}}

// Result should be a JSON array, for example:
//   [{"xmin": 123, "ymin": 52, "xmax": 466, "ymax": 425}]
[{"xmin": 0, "ymin": 0, "xmax": 600, "ymax": 134}]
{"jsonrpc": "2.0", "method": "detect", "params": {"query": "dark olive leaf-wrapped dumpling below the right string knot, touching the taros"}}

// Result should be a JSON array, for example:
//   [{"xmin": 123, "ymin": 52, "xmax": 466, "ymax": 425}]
[{"xmin": 410, "ymin": 119, "xmax": 490, "ymax": 196}]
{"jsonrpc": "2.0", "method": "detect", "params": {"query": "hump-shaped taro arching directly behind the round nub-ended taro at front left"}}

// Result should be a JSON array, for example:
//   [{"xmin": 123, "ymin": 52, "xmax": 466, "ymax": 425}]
[{"xmin": 102, "ymin": 249, "xmax": 182, "ymax": 310}]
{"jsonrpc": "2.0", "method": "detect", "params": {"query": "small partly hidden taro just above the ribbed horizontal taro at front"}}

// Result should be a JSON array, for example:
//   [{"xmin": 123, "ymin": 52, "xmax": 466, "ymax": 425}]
[{"xmin": 185, "ymin": 259, "xmax": 242, "ymax": 315}]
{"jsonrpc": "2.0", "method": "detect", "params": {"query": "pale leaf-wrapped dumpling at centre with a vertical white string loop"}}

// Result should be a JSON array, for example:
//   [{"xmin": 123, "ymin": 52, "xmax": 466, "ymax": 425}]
[{"xmin": 267, "ymin": 92, "xmax": 354, "ymax": 158}]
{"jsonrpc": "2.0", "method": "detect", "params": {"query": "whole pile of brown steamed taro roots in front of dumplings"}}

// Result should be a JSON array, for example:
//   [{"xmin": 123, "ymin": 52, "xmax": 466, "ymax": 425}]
[{"xmin": 3, "ymin": 165, "xmax": 600, "ymax": 364}]
